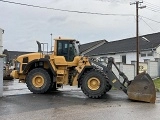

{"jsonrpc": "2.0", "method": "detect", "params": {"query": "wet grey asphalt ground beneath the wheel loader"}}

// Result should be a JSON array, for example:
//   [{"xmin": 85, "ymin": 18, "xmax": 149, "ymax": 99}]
[{"xmin": 0, "ymin": 81, "xmax": 160, "ymax": 120}]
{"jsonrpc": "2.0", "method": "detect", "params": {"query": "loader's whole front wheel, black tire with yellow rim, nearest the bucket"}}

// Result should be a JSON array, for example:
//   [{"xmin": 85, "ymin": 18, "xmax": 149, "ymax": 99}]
[{"xmin": 81, "ymin": 69, "xmax": 111, "ymax": 98}]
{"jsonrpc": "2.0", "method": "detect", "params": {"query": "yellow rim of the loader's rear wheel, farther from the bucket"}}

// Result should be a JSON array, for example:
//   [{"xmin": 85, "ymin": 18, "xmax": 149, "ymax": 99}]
[{"xmin": 32, "ymin": 75, "xmax": 44, "ymax": 87}]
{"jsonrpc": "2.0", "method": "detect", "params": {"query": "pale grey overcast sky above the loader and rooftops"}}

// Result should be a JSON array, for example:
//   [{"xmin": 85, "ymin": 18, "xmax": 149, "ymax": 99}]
[{"xmin": 0, "ymin": 0, "xmax": 160, "ymax": 52}]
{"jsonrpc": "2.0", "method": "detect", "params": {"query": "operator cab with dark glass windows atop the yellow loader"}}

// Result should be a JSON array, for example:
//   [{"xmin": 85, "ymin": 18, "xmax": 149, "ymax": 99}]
[{"xmin": 55, "ymin": 37, "xmax": 79, "ymax": 62}]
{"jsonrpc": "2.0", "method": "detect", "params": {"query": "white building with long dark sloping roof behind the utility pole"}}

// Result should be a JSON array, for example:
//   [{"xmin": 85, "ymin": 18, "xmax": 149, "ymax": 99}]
[{"xmin": 85, "ymin": 32, "xmax": 160, "ymax": 64}]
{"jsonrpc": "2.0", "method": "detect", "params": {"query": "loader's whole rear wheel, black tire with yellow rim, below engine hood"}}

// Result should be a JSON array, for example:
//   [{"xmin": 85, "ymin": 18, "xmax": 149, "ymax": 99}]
[{"xmin": 26, "ymin": 68, "xmax": 51, "ymax": 94}]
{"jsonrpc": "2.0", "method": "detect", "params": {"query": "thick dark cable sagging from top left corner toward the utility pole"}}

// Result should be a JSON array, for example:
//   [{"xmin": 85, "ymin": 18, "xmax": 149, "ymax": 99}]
[{"xmin": 0, "ymin": 0, "xmax": 134, "ymax": 16}]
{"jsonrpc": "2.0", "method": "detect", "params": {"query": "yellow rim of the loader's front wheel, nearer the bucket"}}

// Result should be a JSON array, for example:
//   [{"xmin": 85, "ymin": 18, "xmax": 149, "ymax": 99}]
[{"xmin": 88, "ymin": 77, "xmax": 100, "ymax": 90}]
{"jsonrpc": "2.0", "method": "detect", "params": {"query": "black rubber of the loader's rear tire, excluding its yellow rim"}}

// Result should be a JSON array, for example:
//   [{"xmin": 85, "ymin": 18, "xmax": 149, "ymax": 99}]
[{"xmin": 26, "ymin": 68, "xmax": 51, "ymax": 94}]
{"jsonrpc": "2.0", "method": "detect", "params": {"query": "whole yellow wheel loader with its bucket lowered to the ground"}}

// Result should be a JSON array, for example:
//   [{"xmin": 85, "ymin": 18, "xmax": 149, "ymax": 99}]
[{"xmin": 11, "ymin": 37, "xmax": 156, "ymax": 103}]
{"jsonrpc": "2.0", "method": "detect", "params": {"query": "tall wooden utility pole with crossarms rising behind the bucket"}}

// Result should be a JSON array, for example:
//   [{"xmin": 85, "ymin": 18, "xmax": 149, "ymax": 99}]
[{"xmin": 130, "ymin": 1, "xmax": 146, "ymax": 75}]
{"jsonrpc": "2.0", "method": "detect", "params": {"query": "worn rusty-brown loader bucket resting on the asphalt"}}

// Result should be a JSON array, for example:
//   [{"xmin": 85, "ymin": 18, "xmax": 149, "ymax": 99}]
[{"xmin": 127, "ymin": 72, "xmax": 156, "ymax": 103}]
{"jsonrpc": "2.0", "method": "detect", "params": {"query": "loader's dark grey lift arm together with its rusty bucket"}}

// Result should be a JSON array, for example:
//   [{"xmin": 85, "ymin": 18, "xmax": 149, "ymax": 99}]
[{"xmin": 90, "ymin": 57, "xmax": 156, "ymax": 103}]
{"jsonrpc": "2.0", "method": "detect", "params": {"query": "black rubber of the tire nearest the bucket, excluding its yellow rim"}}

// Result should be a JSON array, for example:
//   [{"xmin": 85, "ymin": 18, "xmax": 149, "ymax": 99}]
[{"xmin": 80, "ymin": 69, "xmax": 111, "ymax": 98}]
